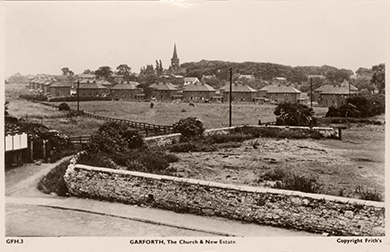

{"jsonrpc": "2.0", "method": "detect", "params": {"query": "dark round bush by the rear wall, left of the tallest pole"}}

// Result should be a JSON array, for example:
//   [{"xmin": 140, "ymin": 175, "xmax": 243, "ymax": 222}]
[{"xmin": 173, "ymin": 117, "xmax": 205, "ymax": 142}]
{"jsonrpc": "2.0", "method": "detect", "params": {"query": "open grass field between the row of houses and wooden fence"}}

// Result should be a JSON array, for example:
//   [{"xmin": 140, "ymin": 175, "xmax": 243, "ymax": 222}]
[{"xmin": 50, "ymin": 101, "xmax": 327, "ymax": 129}]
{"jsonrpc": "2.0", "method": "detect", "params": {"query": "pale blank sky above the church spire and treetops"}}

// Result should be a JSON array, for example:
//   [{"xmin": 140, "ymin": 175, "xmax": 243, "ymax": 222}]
[{"xmin": 3, "ymin": 1, "xmax": 389, "ymax": 77}]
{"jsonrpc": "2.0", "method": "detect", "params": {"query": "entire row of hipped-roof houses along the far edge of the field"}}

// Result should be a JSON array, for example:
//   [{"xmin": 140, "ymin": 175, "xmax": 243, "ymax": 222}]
[{"xmin": 29, "ymin": 74, "xmax": 358, "ymax": 106}]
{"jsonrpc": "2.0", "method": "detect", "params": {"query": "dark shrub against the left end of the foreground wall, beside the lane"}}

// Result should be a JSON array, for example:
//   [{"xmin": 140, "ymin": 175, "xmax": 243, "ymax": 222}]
[{"xmin": 38, "ymin": 160, "xmax": 70, "ymax": 196}]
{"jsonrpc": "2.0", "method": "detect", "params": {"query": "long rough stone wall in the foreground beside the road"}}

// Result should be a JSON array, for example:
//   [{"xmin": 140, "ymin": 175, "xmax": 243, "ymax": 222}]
[{"xmin": 64, "ymin": 158, "xmax": 385, "ymax": 236}]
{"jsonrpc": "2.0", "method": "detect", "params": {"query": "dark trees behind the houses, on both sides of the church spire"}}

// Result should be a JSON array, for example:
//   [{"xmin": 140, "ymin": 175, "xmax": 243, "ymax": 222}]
[{"xmin": 61, "ymin": 60, "xmax": 385, "ymax": 94}]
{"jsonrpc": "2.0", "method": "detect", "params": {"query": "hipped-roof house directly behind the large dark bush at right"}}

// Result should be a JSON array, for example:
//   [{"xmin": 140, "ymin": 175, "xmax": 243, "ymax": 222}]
[{"xmin": 258, "ymin": 85, "xmax": 301, "ymax": 103}]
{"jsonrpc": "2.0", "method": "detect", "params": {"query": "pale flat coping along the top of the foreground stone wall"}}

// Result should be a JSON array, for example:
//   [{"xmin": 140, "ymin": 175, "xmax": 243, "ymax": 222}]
[{"xmin": 74, "ymin": 164, "xmax": 385, "ymax": 208}]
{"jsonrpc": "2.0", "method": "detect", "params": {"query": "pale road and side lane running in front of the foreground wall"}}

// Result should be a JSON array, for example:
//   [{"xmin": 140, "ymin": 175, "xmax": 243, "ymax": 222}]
[{"xmin": 5, "ymin": 158, "xmax": 318, "ymax": 237}]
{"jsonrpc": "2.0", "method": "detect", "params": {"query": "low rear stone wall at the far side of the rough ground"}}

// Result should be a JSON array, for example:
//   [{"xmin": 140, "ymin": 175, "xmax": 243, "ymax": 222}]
[{"xmin": 145, "ymin": 125, "xmax": 340, "ymax": 147}]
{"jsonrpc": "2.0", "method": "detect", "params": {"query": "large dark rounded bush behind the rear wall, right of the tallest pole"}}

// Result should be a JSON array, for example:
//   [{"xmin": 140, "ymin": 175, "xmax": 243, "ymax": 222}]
[{"xmin": 274, "ymin": 102, "xmax": 317, "ymax": 127}]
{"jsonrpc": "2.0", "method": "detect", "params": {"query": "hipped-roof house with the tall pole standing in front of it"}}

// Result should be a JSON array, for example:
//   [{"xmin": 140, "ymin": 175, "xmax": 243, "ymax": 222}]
[{"xmin": 221, "ymin": 82, "xmax": 257, "ymax": 102}]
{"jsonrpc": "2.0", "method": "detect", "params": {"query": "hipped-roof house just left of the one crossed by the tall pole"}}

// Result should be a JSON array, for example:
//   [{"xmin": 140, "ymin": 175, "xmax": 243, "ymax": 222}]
[{"xmin": 183, "ymin": 81, "xmax": 216, "ymax": 102}]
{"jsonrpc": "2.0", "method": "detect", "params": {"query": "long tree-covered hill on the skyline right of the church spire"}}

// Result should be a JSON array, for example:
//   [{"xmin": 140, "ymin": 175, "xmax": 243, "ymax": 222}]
[{"xmin": 181, "ymin": 60, "xmax": 353, "ymax": 84}]
